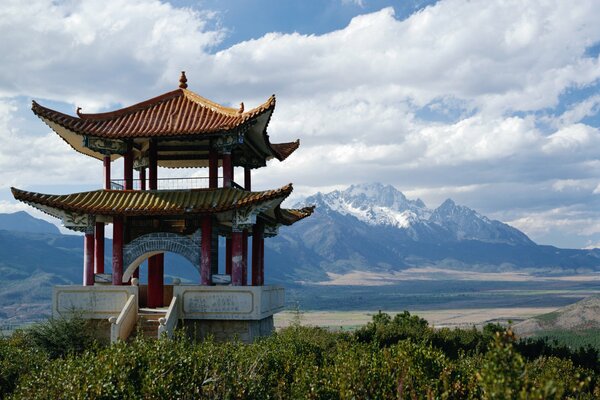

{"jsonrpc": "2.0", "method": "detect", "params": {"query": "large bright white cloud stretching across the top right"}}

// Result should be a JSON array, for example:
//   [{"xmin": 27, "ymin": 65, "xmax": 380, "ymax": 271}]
[{"xmin": 204, "ymin": 0, "xmax": 600, "ymax": 114}]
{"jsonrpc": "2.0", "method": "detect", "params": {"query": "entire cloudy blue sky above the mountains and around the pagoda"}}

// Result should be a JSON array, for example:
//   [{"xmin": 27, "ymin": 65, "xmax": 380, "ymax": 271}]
[{"xmin": 0, "ymin": 0, "xmax": 600, "ymax": 247}]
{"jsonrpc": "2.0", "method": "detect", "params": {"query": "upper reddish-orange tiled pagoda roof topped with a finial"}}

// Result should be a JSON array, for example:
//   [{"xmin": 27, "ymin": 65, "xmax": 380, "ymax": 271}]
[{"xmin": 32, "ymin": 73, "xmax": 299, "ymax": 168}]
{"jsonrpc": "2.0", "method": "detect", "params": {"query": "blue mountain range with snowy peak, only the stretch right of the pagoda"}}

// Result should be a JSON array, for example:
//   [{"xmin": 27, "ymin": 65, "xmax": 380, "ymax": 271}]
[{"xmin": 267, "ymin": 183, "xmax": 600, "ymax": 282}]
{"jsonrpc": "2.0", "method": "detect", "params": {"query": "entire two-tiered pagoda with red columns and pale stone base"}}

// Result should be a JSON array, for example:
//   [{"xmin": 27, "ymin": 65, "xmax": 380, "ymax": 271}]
[{"xmin": 12, "ymin": 72, "xmax": 313, "ymax": 341}]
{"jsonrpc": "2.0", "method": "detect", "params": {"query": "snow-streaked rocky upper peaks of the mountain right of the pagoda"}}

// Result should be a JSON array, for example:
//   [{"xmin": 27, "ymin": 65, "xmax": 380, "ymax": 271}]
[{"xmin": 304, "ymin": 183, "xmax": 534, "ymax": 245}]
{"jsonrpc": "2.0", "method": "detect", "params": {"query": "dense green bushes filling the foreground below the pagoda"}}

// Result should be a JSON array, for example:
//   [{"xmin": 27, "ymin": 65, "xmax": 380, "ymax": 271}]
[{"xmin": 0, "ymin": 313, "xmax": 600, "ymax": 399}]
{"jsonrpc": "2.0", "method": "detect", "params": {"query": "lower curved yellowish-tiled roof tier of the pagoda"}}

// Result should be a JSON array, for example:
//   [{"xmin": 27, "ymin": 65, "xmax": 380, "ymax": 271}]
[{"xmin": 11, "ymin": 184, "xmax": 314, "ymax": 231}]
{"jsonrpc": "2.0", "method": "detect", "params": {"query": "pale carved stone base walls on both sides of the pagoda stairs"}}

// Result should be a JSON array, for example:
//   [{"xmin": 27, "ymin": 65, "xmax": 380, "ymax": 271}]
[{"xmin": 52, "ymin": 285, "xmax": 285, "ymax": 343}]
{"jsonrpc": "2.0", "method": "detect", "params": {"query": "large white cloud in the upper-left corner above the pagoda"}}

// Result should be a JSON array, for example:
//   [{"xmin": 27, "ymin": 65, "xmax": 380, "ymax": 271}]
[{"xmin": 0, "ymin": 0, "xmax": 222, "ymax": 110}]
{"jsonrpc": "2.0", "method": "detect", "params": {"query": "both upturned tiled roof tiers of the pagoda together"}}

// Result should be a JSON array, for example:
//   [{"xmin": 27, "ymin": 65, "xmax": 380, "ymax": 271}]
[{"xmin": 12, "ymin": 73, "xmax": 312, "ymax": 234}]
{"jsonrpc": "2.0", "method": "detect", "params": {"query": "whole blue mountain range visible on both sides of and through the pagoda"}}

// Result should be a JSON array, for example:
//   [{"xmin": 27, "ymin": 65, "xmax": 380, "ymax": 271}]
[{"xmin": 0, "ymin": 183, "xmax": 600, "ymax": 320}]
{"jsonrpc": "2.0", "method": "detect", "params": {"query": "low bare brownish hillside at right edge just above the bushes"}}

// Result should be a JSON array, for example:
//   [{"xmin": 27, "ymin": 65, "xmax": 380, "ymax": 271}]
[{"xmin": 514, "ymin": 295, "xmax": 600, "ymax": 336}]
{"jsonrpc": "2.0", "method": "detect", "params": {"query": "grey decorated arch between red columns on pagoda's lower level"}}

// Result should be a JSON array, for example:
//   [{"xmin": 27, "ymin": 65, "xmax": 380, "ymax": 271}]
[{"xmin": 123, "ymin": 230, "xmax": 201, "ymax": 282}]
